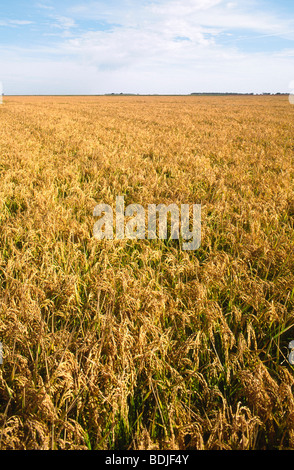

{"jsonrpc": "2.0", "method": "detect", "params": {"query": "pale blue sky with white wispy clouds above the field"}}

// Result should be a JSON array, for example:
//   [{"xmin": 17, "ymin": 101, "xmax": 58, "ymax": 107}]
[{"xmin": 0, "ymin": 0, "xmax": 294, "ymax": 94}]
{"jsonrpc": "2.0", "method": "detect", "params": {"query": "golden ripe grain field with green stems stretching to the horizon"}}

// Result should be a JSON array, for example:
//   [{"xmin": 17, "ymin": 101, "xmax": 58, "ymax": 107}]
[{"xmin": 0, "ymin": 96, "xmax": 294, "ymax": 450}]
